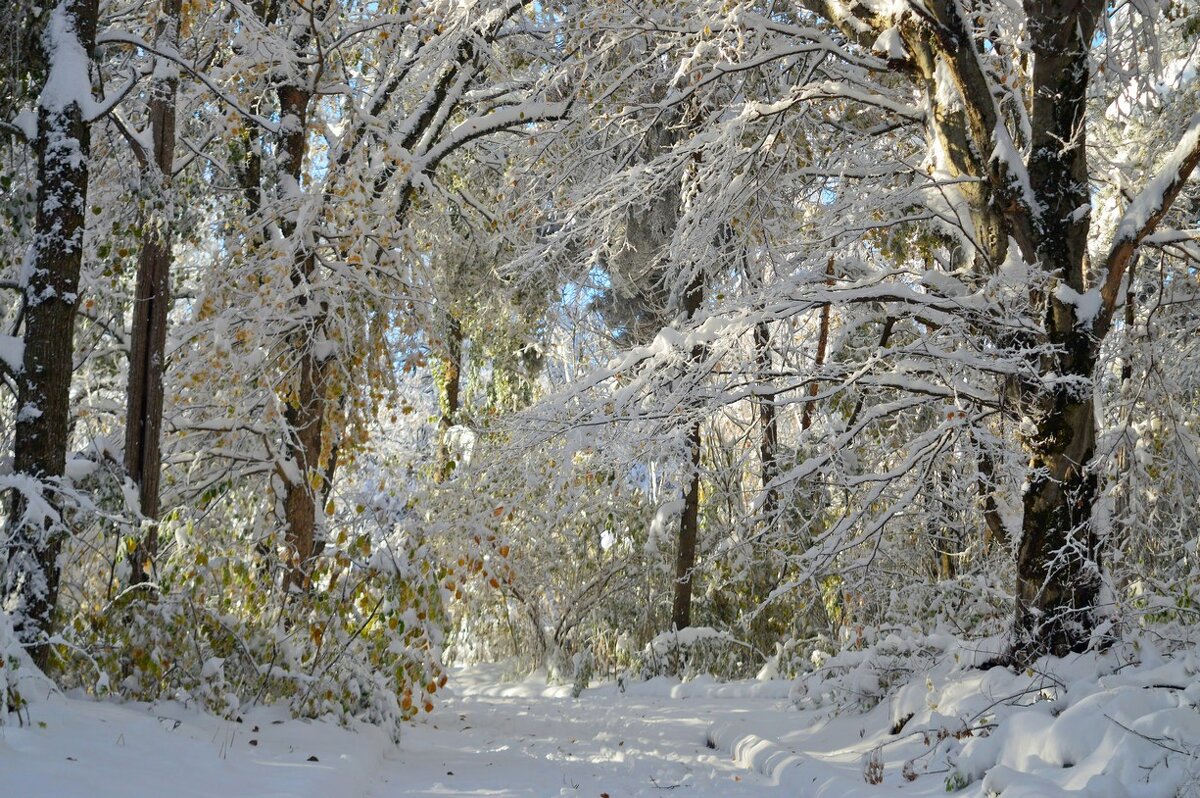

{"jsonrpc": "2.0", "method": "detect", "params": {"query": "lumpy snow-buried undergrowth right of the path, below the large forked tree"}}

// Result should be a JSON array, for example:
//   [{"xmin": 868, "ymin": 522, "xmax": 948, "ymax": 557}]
[{"xmin": 709, "ymin": 636, "xmax": 1200, "ymax": 798}]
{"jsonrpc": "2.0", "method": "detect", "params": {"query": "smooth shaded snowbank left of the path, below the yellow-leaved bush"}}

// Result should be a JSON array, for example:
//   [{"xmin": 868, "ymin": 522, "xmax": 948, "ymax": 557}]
[{"xmin": 0, "ymin": 612, "xmax": 391, "ymax": 798}]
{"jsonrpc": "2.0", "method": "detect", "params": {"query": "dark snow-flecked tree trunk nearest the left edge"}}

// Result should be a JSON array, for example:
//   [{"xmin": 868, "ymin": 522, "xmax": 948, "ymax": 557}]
[{"xmin": 4, "ymin": 0, "xmax": 97, "ymax": 667}]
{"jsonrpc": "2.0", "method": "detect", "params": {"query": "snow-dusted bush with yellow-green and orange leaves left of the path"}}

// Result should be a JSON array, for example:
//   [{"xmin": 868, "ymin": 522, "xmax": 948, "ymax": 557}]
[{"xmin": 49, "ymin": 506, "xmax": 445, "ymax": 731}]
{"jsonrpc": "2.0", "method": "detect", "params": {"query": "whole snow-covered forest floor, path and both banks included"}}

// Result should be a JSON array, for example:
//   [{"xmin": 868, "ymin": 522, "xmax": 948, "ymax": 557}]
[{"xmin": 7, "ymin": 638, "xmax": 1200, "ymax": 798}]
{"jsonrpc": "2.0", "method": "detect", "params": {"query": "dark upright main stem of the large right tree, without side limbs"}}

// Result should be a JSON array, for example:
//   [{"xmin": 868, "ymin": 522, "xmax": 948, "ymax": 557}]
[{"xmin": 1013, "ymin": 0, "xmax": 1103, "ymax": 662}]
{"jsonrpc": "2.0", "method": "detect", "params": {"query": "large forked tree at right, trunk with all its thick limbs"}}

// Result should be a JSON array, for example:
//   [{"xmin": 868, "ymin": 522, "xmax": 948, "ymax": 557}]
[{"xmin": 802, "ymin": 0, "xmax": 1200, "ymax": 662}]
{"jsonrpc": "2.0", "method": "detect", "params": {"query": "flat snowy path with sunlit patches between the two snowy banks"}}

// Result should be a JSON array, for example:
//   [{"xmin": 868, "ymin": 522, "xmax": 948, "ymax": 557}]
[{"xmin": 370, "ymin": 680, "xmax": 780, "ymax": 798}]
